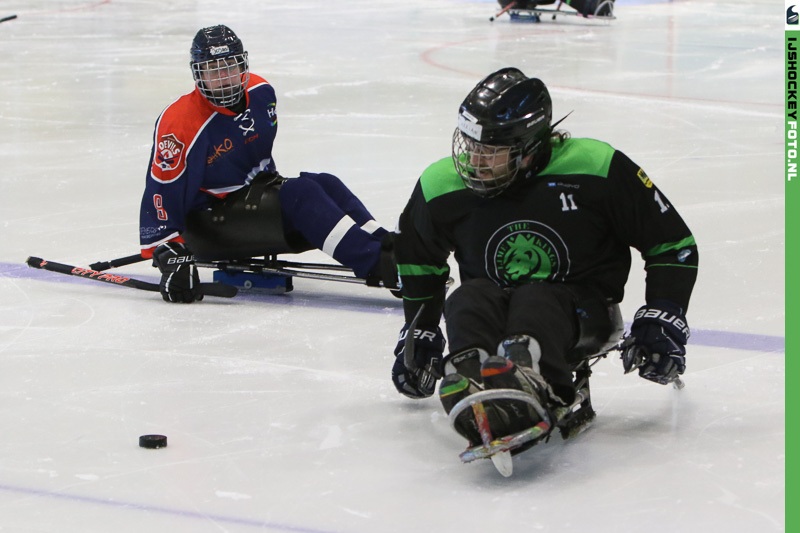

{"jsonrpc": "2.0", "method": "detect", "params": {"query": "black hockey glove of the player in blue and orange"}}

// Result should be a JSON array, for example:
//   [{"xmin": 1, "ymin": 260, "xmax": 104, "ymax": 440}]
[{"xmin": 153, "ymin": 242, "xmax": 203, "ymax": 303}]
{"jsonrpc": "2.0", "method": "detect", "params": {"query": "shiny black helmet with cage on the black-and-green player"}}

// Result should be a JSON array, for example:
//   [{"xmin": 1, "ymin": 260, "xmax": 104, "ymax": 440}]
[{"xmin": 453, "ymin": 68, "xmax": 553, "ymax": 197}]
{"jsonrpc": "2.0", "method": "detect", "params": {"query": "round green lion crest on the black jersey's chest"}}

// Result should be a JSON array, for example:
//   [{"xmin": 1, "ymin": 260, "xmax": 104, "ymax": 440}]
[{"xmin": 486, "ymin": 220, "xmax": 570, "ymax": 287}]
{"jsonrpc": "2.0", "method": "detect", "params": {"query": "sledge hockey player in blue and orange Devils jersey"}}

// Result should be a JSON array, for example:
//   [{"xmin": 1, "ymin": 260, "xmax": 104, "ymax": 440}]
[{"xmin": 139, "ymin": 25, "xmax": 387, "ymax": 303}]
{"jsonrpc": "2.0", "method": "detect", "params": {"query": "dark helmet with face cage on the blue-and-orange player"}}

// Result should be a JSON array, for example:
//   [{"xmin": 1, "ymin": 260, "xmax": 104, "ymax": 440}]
[{"xmin": 189, "ymin": 24, "xmax": 250, "ymax": 107}]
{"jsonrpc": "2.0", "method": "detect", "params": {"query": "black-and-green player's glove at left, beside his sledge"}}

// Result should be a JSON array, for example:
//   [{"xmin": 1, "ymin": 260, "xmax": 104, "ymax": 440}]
[{"xmin": 392, "ymin": 324, "xmax": 445, "ymax": 399}]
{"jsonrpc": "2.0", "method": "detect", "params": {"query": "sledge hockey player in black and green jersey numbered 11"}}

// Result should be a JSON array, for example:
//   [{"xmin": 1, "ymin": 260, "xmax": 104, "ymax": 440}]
[{"xmin": 392, "ymin": 68, "xmax": 698, "ymax": 470}]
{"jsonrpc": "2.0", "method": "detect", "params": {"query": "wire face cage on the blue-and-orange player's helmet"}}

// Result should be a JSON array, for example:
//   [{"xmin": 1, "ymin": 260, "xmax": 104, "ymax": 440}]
[{"xmin": 191, "ymin": 52, "xmax": 250, "ymax": 107}]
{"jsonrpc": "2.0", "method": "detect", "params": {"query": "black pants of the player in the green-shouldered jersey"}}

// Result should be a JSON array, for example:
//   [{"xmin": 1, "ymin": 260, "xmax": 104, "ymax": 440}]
[{"xmin": 444, "ymin": 279, "xmax": 613, "ymax": 401}]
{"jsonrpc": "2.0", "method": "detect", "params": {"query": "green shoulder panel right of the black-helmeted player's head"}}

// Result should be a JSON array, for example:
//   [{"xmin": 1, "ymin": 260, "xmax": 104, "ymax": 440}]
[{"xmin": 539, "ymin": 139, "xmax": 614, "ymax": 178}]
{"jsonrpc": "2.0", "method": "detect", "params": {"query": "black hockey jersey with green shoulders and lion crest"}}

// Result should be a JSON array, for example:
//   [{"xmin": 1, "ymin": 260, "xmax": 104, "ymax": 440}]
[{"xmin": 395, "ymin": 139, "xmax": 698, "ymax": 326}]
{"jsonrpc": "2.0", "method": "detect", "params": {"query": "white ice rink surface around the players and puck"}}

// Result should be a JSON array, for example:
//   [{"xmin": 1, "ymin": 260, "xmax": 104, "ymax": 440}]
[{"xmin": 0, "ymin": 0, "xmax": 785, "ymax": 533}]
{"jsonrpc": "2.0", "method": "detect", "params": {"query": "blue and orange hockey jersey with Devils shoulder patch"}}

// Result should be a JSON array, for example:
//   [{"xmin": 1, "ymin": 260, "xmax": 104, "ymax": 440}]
[{"xmin": 139, "ymin": 73, "xmax": 278, "ymax": 258}]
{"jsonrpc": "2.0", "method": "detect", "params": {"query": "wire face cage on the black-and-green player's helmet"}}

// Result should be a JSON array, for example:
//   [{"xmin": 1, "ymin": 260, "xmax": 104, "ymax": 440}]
[{"xmin": 453, "ymin": 128, "xmax": 523, "ymax": 198}]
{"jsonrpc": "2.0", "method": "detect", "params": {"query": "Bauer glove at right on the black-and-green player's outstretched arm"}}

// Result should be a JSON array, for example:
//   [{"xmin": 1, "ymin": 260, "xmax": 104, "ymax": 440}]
[{"xmin": 622, "ymin": 300, "xmax": 690, "ymax": 385}]
